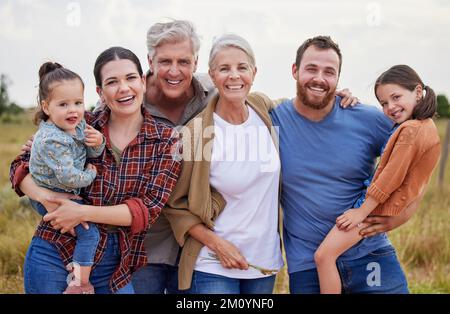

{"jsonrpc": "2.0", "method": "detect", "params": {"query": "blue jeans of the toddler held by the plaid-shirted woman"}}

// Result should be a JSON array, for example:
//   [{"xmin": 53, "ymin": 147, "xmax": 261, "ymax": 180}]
[{"xmin": 30, "ymin": 199, "xmax": 100, "ymax": 266}]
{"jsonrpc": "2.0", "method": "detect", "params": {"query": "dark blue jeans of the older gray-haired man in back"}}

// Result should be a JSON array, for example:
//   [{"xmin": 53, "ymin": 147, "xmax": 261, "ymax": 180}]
[{"xmin": 132, "ymin": 264, "xmax": 184, "ymax": 294}]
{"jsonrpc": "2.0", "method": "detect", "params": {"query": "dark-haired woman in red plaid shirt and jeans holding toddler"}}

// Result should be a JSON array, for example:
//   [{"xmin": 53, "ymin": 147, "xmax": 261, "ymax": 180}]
[{"xmin": 10, "ymin": 47, "xmax": 181, "ymax": 293}]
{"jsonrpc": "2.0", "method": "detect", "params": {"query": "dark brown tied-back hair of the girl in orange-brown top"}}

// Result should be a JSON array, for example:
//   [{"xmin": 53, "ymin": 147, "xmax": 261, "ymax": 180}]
[{"xmin": 374, "ymin": 64, "xmax": 437, "ymax": 120}]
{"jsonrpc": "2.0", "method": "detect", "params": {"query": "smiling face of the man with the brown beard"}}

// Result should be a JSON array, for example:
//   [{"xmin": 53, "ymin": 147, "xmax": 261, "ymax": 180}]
[{"xmin": 292, "ymin": 46, "xmax": 339, "ymax": 110}]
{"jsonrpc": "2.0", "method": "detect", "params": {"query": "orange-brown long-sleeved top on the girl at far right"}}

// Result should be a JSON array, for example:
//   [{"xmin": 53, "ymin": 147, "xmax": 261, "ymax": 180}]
[{"xmin": 367, "ymin": 119, "xmax": 441, "ymax": 216}]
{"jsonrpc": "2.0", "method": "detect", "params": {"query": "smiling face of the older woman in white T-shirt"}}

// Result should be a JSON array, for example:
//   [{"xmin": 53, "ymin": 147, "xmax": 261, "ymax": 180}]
[{"xmin": 209, "ymin": 47, "xmax": 256, "ymax": 103}]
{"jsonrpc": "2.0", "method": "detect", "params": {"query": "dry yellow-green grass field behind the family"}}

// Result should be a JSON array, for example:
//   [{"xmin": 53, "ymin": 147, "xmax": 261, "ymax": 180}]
[{"xmin": 0, "ymin": 114, "xmax": 450, "ymax": 293}]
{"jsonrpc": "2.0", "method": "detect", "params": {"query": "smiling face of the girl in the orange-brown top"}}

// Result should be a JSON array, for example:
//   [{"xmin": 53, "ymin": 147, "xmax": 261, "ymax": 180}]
[{"xmin": 376, "ymin": 84, "xmax": 422, "ymax": 124}]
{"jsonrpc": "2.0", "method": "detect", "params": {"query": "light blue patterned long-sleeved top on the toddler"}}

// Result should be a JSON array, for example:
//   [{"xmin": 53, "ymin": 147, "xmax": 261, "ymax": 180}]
[{"xmin": 30, "ymin": 119, "xmax": 105, "ymax": 194}]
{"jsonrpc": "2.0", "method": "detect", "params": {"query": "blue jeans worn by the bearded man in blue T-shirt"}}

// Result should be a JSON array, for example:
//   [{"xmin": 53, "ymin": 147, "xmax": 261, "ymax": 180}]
[{"xmin": 289, "ymin": 245, "xmax": 409, "ymax": 294}]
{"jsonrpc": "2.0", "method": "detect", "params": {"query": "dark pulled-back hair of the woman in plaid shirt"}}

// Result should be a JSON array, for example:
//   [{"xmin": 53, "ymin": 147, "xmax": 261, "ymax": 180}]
[{"xmin": 94, "ymin": 47, "xmax": 143, "ymax": 87}]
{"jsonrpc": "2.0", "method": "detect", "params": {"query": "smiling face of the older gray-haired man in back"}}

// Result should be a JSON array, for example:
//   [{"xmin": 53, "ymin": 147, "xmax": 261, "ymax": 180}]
[{"xmin": 149, "ymin": 39, "xmax": 197, "ymax": 100}]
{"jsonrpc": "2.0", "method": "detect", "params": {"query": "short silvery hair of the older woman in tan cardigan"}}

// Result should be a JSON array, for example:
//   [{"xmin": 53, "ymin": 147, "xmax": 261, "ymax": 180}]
[{"xmin": 208, "ymin": 34, "xmax": 256, "ymax": 69}]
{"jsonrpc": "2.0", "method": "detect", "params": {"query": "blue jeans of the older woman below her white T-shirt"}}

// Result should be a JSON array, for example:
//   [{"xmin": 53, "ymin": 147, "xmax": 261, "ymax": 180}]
[{"xmin": 188, "ymin": 270, "xmax": 275, "ymax": 294}]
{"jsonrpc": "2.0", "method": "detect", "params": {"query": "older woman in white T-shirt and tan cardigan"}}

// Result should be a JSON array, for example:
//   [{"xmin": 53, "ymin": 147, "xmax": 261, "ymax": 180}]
[{"xmin": 164, "ymin": 34, "xmax": 283, "ymax": 294}]
